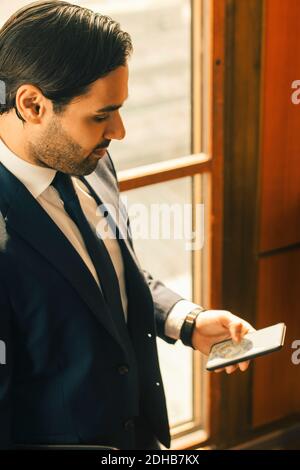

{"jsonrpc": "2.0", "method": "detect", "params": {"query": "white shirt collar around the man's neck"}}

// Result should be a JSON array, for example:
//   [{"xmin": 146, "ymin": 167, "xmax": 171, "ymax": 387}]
[{"xmin": 0, "ymin": 137, "xmax": 56, "ymax": 199}]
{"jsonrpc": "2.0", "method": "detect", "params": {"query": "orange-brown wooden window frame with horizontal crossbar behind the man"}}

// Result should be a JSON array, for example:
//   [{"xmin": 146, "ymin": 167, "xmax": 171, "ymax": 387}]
[{"xmin": 118, "ymin": 0, "xmax": 225, "ymax": 449}]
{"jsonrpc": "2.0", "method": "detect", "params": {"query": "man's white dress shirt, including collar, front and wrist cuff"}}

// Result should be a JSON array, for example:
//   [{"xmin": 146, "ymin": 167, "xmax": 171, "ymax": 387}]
[{"xmin": 0, "ymin": 138, "xmax": 197, "ymax": 339}]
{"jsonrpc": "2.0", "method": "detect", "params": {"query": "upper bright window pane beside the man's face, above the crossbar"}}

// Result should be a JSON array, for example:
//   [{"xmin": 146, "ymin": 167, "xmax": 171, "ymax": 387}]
[{"xmin": 98, "ymin": 0, "xmax": 191, "ymax": 170}]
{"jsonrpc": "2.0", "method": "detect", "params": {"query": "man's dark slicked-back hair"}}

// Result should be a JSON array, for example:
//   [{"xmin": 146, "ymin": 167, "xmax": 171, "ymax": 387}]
[{"xmin": 0, "ymin": 1, "xmax": 133, "ymax": 121}]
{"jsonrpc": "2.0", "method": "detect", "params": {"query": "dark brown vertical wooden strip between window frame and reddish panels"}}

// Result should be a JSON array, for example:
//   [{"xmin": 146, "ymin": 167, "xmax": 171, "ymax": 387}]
[{"xmin": 220, "ymin": 0, "xmax": 263, "ymax": 448}]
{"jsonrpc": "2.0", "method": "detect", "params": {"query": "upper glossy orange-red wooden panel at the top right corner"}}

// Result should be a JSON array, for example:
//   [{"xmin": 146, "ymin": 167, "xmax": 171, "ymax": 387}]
[{"xmin": 259, "ymin": 0, "xmax": 300, "ymax": 252}]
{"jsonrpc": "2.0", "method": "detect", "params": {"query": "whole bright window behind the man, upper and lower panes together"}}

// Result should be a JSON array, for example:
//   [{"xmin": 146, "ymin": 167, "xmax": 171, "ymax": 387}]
[{"xmin": 78, "ymin": 0, "xmax": 210, "ymax": 448}]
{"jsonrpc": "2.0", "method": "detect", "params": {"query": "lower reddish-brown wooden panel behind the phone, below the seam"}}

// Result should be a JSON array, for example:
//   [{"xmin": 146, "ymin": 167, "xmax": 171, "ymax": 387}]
[{"xmin": 252, "ymin": 249, "xmax": 300, "ymax": 426}]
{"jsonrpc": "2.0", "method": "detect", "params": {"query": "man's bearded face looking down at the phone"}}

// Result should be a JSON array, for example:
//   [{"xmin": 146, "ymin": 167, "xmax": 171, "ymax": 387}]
[{"xmin": 27, "ymin": 65, "xmax": 128, "ymax": 176}]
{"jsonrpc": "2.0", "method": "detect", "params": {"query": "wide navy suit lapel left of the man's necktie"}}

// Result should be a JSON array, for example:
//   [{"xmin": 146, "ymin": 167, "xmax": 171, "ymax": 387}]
[{"xmin": 0, "ymin": 164, "xmax": 126, "ymax": 350}]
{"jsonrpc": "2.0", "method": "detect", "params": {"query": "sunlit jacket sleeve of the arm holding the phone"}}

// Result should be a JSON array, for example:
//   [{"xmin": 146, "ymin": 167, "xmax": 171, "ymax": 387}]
[{"xmin": 107, "ymin": 152, "xmax": 184, "ymax": 344}]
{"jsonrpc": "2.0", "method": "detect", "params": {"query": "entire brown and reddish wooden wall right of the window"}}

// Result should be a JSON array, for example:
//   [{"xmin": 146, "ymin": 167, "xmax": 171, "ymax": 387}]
[{"xmin": 218, "ymin": 0, "xmax": 300, "ymax": 448}]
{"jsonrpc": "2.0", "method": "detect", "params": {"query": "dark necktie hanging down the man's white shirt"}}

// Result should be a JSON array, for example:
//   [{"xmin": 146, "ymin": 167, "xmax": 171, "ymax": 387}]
[{"xmin": 52, "ymin": 171, "xmax": 126, "ymax": 327}]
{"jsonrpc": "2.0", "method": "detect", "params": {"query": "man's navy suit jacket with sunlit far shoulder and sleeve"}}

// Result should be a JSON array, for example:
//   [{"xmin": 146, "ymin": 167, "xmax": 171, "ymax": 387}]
[{"xmin": 0, "ymin": 153, "xmax": 181, "ymax": 449}]
